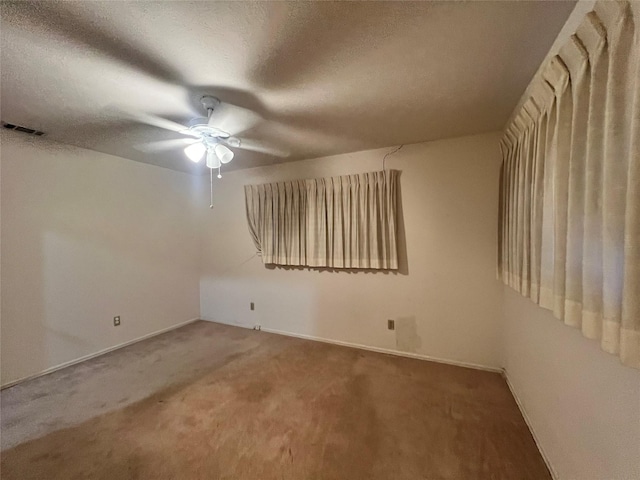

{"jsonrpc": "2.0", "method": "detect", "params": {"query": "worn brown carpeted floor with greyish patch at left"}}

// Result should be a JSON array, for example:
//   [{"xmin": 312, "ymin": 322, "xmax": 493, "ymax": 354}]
[{"xmin": 1, "ymin": 322, "xmax": 551, "ymax": 480}]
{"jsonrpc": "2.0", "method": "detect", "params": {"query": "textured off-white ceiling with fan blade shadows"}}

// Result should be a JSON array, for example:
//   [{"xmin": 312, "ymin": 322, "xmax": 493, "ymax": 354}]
[{"xmin": 0, "ymin": 1, "xmax": 575, "ymax": 176}]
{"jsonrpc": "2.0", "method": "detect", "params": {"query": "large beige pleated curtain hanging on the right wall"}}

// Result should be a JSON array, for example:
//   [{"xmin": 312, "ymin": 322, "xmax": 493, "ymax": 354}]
[{"xmin": 498, "ymin": 1, "xmax": 640, "ymax": 368}]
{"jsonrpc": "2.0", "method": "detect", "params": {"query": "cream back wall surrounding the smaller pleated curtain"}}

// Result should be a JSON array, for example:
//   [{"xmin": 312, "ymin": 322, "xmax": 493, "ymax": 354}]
[{"xmin": 200, "ymin": 133, "xmax": 502, "ymax": 367}]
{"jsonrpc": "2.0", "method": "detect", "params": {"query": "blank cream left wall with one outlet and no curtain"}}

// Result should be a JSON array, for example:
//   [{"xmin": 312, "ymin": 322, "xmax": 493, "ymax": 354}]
[{"xmin": 0, "ymin": 130, "xmax": 199, "ymax": 384}]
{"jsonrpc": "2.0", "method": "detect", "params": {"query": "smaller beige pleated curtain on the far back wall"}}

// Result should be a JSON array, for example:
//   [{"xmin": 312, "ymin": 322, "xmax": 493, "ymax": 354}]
[{"xmin": 245, "ymin": 170, "xmax": 398, "ymax": 270}]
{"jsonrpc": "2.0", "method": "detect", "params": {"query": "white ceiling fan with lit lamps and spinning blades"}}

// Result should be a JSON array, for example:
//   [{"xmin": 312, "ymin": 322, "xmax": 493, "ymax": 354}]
[{"xmin": 134, "ymin": 95, "xmax": 288, "ymax": 178}]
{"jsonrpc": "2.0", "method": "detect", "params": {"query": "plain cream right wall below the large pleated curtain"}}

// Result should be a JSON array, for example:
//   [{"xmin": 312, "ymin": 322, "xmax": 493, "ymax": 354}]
[{"xmin": 504, "ymin": 287, "xmax": 640, "ymax": 480}]
